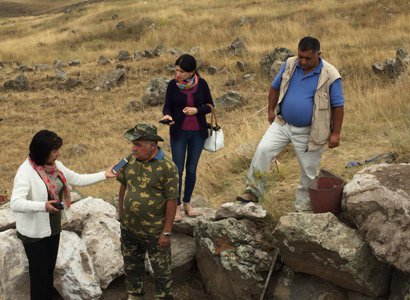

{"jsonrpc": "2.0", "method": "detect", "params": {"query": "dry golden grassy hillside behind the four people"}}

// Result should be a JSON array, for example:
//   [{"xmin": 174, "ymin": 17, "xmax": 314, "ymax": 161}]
[{"xmin": 0, "ymin": 0, "xmax": 410, "ymax": 220}]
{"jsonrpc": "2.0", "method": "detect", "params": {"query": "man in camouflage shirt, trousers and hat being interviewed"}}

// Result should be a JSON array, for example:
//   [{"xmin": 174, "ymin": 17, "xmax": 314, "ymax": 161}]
[{"xmin": 117, "ymin": 124, "xmax": 178, "ymax": 299}]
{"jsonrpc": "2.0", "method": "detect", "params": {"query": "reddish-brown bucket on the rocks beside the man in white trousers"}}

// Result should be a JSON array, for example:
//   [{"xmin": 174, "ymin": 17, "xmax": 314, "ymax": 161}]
[{"xmin": 308, "ymin": 176, "xmax": 345, "ymax": 214}]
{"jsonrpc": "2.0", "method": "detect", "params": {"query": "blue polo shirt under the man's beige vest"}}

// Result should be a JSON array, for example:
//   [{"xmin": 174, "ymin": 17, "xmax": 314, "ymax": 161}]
[{"xmin": 272, "ymin": 59, "xmax": 344, "ymax": 127}]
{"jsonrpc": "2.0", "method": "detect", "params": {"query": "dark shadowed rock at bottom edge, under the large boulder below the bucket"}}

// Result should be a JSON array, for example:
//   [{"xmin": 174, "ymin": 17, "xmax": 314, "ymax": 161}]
[{"xmin": 268, "ymin": 266, "xmax": 350, "ymax": 300}]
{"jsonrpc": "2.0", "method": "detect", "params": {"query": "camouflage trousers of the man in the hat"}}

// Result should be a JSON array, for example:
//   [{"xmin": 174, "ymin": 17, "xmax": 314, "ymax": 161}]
[{"xmin": 121, "ymin": 226, "xmax": 172, "ymax": 299}]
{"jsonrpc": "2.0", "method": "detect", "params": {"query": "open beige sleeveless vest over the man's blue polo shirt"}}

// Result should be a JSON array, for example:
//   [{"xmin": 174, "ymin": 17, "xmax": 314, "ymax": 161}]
[{"xmin": 275, "ymin": 57, "xmax": 341, "ymax": 150}]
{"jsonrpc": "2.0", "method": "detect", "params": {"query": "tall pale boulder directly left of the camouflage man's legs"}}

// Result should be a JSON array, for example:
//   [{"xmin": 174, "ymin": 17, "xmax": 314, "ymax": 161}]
[{"xmin": 81, "ymin": 215, "xmax": 124, "ymax": 289}]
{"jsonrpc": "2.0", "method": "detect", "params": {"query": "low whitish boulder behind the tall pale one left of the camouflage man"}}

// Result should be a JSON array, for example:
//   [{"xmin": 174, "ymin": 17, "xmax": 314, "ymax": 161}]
[{"xmin": 63, "ymin": 197, "xmax": 117, "ymax": 235}]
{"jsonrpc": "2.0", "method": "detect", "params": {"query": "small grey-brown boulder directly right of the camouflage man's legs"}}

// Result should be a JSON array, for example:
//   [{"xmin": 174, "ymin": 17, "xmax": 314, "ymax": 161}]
[{"xmin": 171, "ymin": 233, "xmax": 195, "ymax": 282}]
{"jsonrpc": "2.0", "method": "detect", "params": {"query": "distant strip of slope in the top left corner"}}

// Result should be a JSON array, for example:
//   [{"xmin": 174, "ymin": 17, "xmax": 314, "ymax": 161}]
[{"xmin": 0, "ymin": 0, "xmax": 103, "ymax": 18}]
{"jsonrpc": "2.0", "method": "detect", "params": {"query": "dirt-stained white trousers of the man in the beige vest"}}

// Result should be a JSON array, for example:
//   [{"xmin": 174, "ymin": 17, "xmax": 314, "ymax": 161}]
[{"xmin": 246, "ymin": 122, "xmax": 324, "ymax": 211}]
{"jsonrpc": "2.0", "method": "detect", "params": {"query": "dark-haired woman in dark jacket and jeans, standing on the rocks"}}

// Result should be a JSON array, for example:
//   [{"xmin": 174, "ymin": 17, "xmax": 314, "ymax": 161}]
[{"xmin": 162, "ymin": 54, "xmax": 214, "ymax": 221}]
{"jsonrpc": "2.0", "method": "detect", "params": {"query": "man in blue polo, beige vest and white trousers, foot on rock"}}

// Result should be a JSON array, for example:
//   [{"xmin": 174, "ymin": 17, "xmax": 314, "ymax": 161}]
[{"xmin": 237, "ymin": 37, "xmax": 344, "ymax": 211}]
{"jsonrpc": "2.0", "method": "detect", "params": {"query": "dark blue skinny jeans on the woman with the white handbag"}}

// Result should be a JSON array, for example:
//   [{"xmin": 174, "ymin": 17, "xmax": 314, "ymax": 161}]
[{"xmin": 171, "ymin": 130, "xmax": 205, "ymax": 205}]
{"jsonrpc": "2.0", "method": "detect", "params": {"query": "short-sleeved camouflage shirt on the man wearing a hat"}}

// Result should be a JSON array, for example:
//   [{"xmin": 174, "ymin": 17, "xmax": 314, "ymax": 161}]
[{"xmin": 117, "ymin": 149, "xmax": 178, "ymax": 236}]
